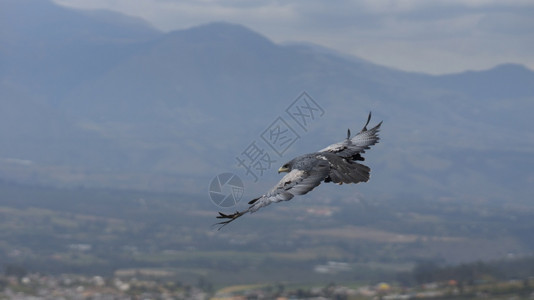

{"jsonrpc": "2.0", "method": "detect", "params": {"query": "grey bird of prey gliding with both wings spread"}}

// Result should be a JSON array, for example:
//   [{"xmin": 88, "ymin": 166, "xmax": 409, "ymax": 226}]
[{"xmin": 215, "ymin": 113, "xmax": 382, "ymax": 229}]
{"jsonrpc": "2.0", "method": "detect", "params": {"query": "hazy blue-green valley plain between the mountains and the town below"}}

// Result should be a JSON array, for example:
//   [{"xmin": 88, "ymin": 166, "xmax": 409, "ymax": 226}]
[{"xmin": 0, "ymin": 180, "xmax": 534, "ymax": 286}]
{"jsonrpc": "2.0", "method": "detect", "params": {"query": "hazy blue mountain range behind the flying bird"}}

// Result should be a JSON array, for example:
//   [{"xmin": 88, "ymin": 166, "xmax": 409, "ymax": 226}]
[{"xmin": 0, "ymin": 0, "xmax": 534, "ymax": 201}]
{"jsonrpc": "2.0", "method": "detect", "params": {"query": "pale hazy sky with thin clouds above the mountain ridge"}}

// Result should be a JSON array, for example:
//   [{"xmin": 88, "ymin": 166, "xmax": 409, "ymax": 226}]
[{"xmin": 54, "ymin": 0, "xmax": 534, "ymax": 74}]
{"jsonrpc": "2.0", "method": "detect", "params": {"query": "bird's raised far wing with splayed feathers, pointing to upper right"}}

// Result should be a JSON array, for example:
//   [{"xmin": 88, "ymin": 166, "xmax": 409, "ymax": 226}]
[{"xmin": 319, "ymin": 113, "xmax": 382, "ymax": 160}]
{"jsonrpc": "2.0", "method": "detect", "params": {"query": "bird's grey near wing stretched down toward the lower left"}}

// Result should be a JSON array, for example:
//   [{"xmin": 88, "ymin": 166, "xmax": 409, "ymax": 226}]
[{"xmin": 214, "ymin": 157, "xmax": 330, "ymax": 230}]
